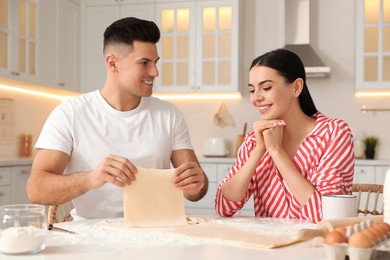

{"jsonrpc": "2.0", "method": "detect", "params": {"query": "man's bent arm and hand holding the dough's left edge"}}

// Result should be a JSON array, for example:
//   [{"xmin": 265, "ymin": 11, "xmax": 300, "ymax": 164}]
[{"xmin": 26, "ymin": 149, "xmax": 137, "ymax": 205}]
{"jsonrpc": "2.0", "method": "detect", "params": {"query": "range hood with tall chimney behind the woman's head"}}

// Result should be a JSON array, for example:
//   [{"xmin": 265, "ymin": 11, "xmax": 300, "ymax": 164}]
[{"xmin": 284, "ymin": 0, "xmax": 330, "ymax": 77}]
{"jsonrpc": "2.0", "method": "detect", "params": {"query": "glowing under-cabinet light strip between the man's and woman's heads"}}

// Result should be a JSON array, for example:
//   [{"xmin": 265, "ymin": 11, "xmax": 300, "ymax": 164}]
[{"xmin": 153, "ymin": 92, "xmax": 242, "ymax": 99}]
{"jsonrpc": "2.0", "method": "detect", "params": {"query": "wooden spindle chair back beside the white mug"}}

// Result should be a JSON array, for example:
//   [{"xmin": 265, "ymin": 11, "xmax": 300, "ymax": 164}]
[{"xmin": 352, "ymin": 184, "xmax": 383, "ymax": 216}]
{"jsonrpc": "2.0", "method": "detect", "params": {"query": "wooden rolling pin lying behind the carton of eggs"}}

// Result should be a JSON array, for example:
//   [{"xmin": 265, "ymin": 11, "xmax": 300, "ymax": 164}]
[{"xmin": 297, "ymin": 215, "xmax": 383, "ymax": 240}]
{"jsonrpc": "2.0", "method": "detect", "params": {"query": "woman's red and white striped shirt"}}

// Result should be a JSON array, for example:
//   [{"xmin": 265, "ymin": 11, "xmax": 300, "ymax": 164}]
[{"xmin": 215, "ymin": 112, "xmax": 355, "ymax": 223}]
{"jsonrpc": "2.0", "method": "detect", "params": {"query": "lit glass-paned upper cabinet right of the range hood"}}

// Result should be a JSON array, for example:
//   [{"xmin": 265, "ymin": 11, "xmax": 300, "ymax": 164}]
[{"xmin": 356, "ymin": 0, "xmax": 390, "ymax": 90}]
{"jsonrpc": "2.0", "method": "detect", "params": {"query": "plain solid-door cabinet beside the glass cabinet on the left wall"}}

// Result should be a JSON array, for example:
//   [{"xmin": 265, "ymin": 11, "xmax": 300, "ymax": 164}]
[{"xmin": 41, "ymin": 0, "xmax": 81, "ymax": 92}]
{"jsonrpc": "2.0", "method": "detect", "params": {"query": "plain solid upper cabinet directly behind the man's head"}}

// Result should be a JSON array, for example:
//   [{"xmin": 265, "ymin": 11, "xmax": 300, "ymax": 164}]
[{"xmin": 81, "ymin": 0, "xmax": 154, "ymax": 93}]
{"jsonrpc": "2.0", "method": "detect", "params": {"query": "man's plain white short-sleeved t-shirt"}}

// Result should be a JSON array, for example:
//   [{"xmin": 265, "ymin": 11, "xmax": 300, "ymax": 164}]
[{"xmin": 35, "ymin": 90, "xmax": 193, "ymax": 219}]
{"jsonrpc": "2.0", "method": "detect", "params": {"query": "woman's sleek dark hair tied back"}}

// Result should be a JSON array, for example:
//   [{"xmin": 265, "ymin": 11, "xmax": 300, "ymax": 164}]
[{"xmin": 250, "ymin": 49, "xmax": 318, "ymax": 116}]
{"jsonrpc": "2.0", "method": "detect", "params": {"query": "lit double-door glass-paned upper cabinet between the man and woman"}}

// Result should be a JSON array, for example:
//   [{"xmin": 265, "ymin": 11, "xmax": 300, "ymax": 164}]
[{"xmin": 155, "ymin": 0, "xmax": 243, "ymax": 93}]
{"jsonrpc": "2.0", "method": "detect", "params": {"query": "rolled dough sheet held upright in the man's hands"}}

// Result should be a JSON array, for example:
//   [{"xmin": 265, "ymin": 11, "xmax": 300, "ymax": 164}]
[{"xmin": 123, "ymin": 167, "xmax": 187, "ymax": 227}]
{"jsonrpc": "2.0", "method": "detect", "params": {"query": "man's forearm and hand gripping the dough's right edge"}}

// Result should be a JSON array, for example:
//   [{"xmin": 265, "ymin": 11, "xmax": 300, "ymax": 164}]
[{"xmin": 172, "ymin": 149, "xmax": 209, "ymax": 201}]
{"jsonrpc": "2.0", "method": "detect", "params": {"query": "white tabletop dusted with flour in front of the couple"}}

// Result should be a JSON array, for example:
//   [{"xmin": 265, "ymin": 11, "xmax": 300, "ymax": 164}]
[{"xmin": 0, "ymin": 218, "xmax": 348, "ymax": 260}]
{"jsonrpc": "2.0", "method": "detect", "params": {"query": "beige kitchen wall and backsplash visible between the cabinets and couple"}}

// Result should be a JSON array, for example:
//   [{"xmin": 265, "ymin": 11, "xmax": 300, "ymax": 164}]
[{"xmin": 0, "ymin": 0, "xmax": 390, "ymax": 159}]
